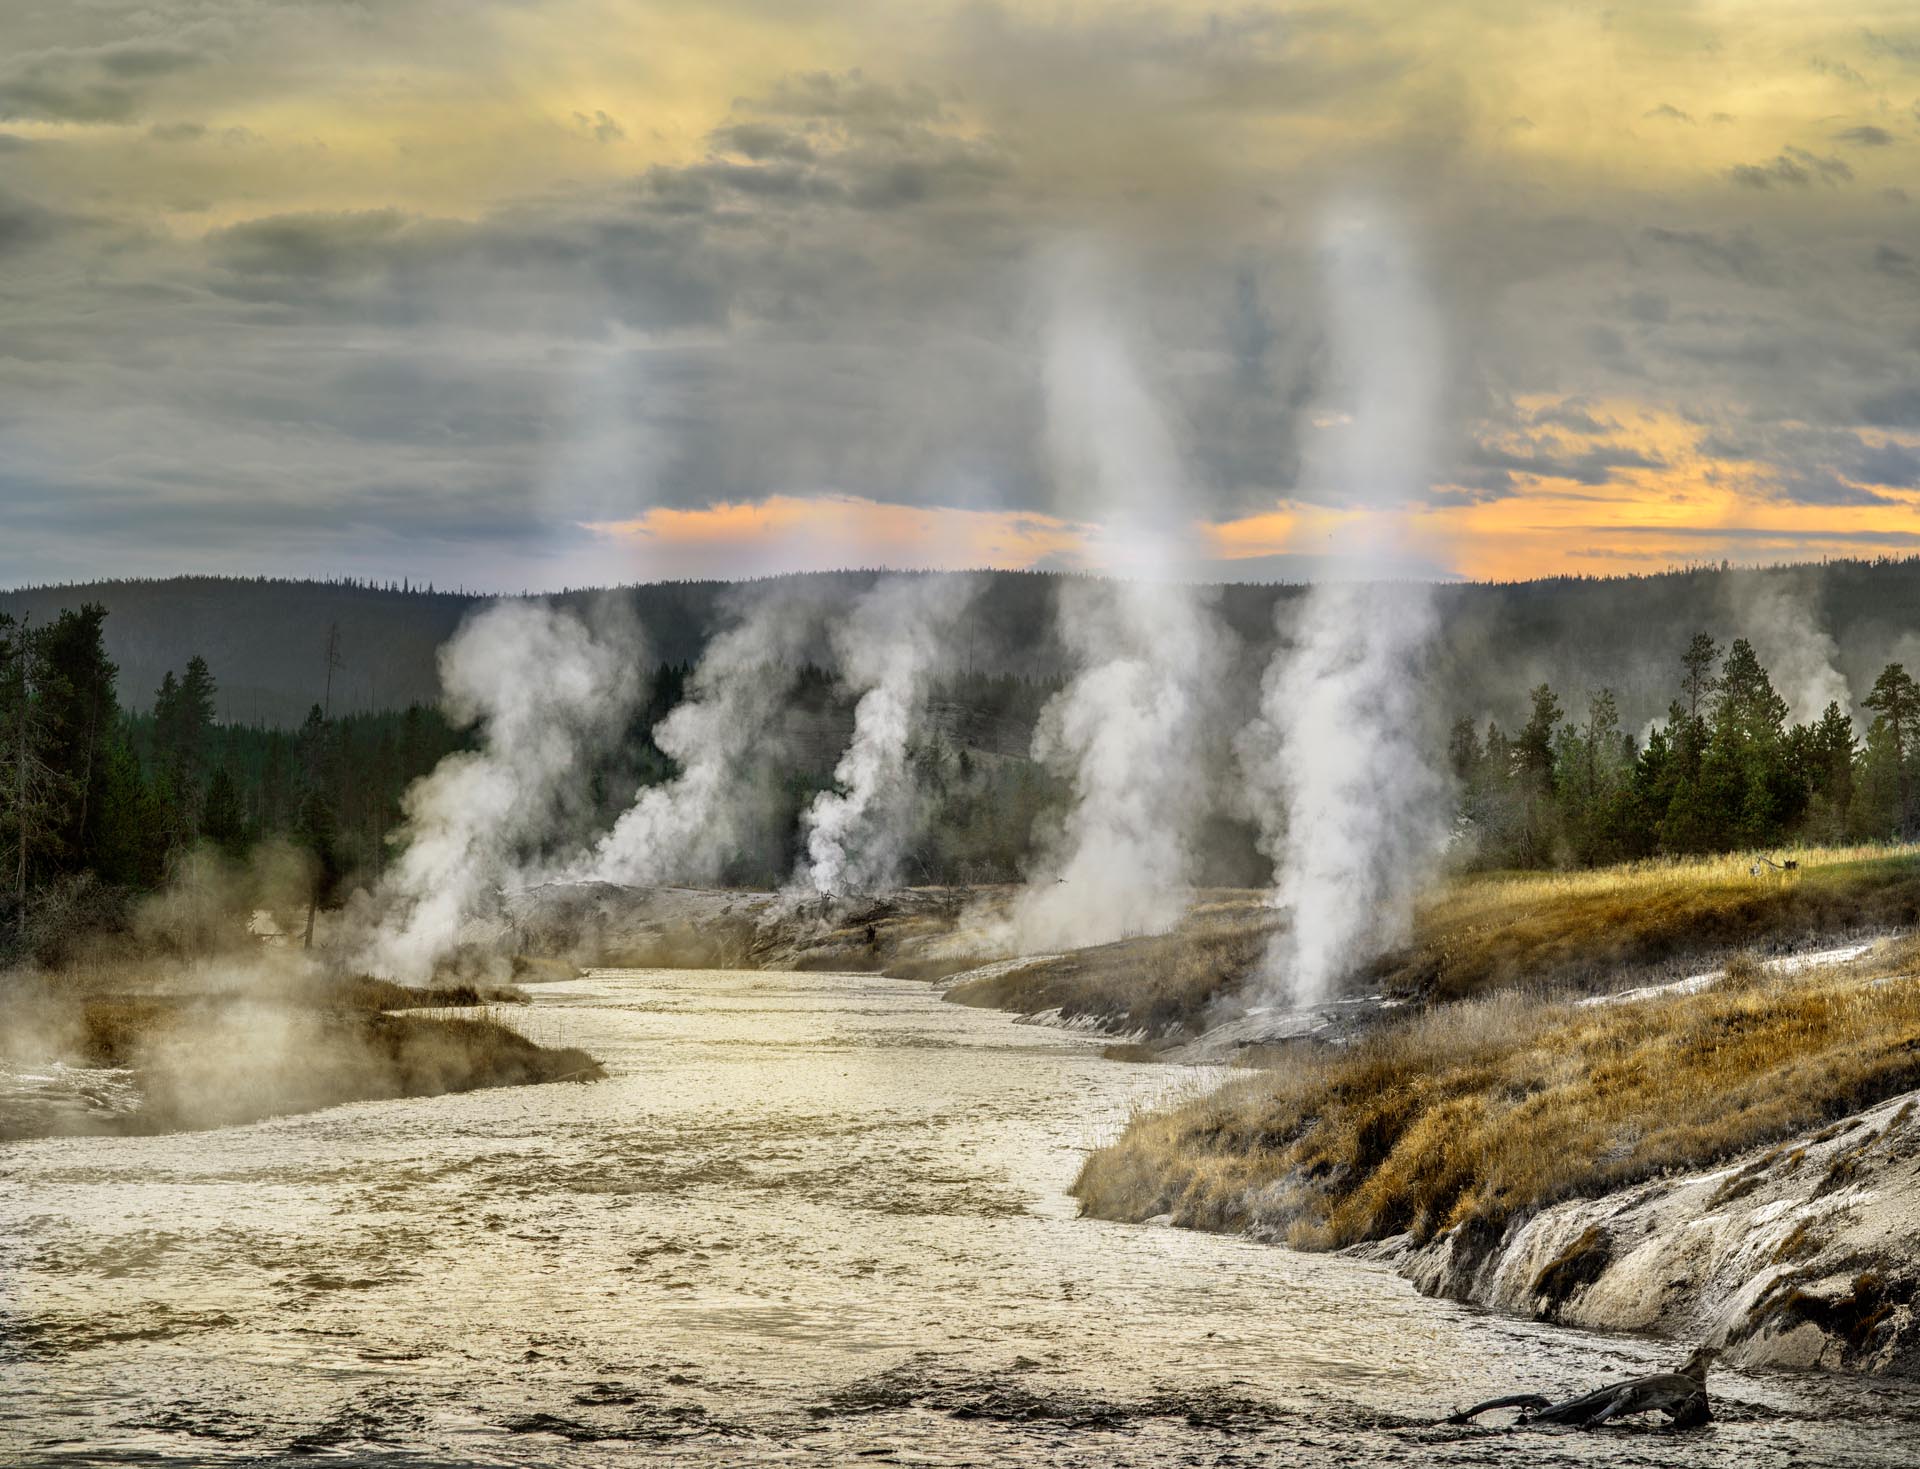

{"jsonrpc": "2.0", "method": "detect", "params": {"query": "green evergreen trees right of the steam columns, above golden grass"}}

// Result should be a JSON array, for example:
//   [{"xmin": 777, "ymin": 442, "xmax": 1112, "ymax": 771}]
[{"xmin": 1448, "ymin": 634, "xmax": 1920, "ymax": 868}]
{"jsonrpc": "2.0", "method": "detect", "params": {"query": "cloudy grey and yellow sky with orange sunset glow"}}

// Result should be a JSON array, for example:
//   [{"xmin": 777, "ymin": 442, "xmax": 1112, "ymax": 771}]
[{"xmin": 0, "ymin": 0, "xmax": 1920, "ymax": 590}]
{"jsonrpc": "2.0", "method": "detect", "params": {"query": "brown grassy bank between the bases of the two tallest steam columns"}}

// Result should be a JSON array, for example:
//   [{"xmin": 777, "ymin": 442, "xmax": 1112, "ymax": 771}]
[{"xmin": 947, "ymin": 899, "xmax": 1277, "ymax": 1037}]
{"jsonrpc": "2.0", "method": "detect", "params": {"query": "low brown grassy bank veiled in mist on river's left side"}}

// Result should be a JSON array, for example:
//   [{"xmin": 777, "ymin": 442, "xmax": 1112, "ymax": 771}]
[{"xmin": 0, "ymin": 964, "xmax": 601, "ymax": 1137}]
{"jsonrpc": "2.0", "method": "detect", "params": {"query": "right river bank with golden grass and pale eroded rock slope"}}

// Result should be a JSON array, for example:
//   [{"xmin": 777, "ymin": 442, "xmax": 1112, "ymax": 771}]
[{"xmin": 1075, "ymin": 855, "xmax": 1920, "ymax": 1377}]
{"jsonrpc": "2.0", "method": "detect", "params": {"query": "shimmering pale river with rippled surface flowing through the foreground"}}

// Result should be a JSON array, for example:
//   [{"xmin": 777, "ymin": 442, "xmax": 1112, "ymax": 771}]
[{"xmin": 0, "ymin": 972, "xmax": 1920, "ymax": 1469}]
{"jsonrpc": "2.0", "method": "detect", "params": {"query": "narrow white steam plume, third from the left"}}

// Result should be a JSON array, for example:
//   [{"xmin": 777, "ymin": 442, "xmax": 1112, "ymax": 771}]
[{"xmin": 799, "ymin": 576, "xmax": 973, "ymax": 893}]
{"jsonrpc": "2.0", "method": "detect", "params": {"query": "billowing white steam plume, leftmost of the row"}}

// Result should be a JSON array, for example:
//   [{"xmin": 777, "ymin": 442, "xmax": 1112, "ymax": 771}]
[{"xmin": 355, "ymin": 603, "xmax": 643, "ymax": 983}]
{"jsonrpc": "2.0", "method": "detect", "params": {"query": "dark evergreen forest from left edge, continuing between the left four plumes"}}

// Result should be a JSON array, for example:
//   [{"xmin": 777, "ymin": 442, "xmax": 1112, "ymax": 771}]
[{"xmin": 0, "ymin": 603, "xmax": 1058, "ymax": 958}]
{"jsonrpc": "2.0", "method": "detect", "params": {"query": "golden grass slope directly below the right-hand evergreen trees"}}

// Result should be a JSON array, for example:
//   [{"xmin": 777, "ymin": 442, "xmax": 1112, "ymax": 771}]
[{"xmin": 1367, "ymin": 847, "xmax": 1920, "ymax": 1000}]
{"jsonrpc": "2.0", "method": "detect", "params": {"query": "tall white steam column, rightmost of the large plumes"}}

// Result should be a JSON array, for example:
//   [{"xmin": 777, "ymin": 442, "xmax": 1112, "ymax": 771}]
[{"xmin": 1240, "ymin": 203, "xmax": 1446, "ymax": 1004}]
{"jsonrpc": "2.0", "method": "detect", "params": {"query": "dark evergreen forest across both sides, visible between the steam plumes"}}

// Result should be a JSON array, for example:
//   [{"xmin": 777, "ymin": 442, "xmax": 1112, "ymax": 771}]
[{"xmin": 0, "ymin": 578, "xmax": 1920, "ymax": 952}]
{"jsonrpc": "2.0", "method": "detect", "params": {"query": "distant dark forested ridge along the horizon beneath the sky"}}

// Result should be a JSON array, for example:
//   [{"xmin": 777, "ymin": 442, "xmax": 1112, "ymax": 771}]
[{"xmin": 0, "ymin": 559, "xmax": 1920, "ymax": 728}]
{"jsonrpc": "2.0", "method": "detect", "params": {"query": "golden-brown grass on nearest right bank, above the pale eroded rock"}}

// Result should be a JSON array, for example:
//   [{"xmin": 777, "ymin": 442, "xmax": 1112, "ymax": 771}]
[{"xmin": 1073, "ymin": 941, "xmax": 1920, "ymax": 1248}]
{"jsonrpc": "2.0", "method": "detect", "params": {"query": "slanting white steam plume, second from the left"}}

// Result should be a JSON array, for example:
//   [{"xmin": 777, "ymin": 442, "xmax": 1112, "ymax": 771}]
[{"xmin": 568, "ymin": 593, "xmax": 818, "ymax": 885}]
